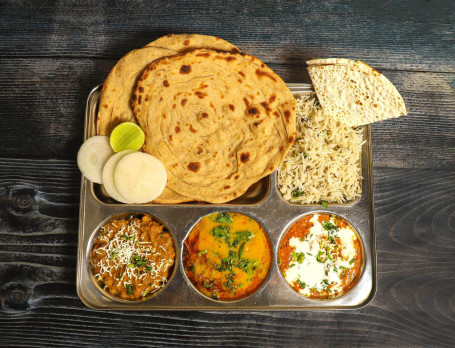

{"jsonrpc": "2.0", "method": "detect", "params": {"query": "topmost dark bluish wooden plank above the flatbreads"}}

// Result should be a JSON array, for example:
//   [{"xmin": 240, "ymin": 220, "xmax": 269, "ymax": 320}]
[{"xmin": 0, "ymin": 0, "xmax": 455, "ymax": 72}]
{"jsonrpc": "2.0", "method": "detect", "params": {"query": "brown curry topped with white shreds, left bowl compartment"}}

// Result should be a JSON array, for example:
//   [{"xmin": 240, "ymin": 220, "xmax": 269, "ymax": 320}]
[{"xmin": 90, "ymin": 215, "xmax": 175, "ymax": 300}]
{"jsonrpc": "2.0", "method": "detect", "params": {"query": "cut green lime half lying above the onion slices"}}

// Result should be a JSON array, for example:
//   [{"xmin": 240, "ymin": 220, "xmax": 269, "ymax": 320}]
[{"xmin": 109, "ymin": 122, "xmax": 145, "ymax": 152}]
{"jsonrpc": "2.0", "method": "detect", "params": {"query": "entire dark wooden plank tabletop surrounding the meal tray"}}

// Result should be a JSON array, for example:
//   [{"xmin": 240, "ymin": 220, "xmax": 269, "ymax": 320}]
[{"xmin": 0, "ymin": 0, "xmax": 455, "ymax": 347}]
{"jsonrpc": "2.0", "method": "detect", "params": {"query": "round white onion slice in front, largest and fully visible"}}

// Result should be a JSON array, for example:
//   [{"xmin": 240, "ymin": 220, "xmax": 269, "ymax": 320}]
[{"xmin": 114, "ymin": 152, "xmax": 167, "ymax": 203}]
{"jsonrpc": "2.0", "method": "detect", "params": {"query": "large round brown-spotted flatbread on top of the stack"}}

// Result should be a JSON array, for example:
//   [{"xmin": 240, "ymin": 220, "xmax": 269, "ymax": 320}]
[{"xmin": 132, "ymin": 49, "xmax": 296, "ymax": 203}]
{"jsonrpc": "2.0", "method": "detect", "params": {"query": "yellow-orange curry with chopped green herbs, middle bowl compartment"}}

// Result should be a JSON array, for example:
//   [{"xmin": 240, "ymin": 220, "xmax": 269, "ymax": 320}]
[{"xmin": 183, "ymin": 212, "xmax": 272, "ymax": 301}]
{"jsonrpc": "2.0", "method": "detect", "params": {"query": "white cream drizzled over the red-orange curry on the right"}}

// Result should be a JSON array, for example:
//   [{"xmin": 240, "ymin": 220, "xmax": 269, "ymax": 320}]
[{"xmin": 284, "ymin": 214, "xmax": 357, "ymax": 296}]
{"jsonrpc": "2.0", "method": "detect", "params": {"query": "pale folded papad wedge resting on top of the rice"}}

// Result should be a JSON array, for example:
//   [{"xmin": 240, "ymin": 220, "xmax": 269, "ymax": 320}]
[{"xmin": 307, "ymin": 58, "xmax": 407, "ymax": 127}]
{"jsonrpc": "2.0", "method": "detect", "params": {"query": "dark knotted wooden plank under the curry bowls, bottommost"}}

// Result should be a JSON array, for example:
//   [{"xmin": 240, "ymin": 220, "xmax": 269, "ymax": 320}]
[{"xmin": 0, "ymin": 159, "xmax": 455, "ymax": 347}]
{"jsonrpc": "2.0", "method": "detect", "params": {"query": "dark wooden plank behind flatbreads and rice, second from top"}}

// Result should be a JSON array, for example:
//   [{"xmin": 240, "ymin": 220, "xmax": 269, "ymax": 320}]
[{"xmin": 0, "ymin": 58, "xmax": 455, "ymax": 168}]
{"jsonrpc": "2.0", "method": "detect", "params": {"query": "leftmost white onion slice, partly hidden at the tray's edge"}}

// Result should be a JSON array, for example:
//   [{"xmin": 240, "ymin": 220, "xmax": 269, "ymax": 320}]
[{"xmin": 77, "ymin": 135, "xmax": 114, "ymax": 184}]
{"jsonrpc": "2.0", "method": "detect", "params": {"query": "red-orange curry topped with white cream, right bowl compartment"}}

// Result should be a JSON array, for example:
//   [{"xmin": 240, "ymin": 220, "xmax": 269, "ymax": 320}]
[{"xmin": 278, "ymin": 213, "xmax": 363, "ymax": 299}]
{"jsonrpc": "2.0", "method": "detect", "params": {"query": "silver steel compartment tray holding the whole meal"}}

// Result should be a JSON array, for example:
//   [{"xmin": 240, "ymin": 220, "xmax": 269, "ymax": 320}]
[{"xmin": 77, "ymin": 83, "xmax": 376, "ymax": 311}]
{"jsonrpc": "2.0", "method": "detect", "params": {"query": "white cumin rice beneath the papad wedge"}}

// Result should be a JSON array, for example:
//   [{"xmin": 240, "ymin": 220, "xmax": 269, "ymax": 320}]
[{"xmin": 278, "ymin": 93, "xmax": 363, "ymax": 204}]
